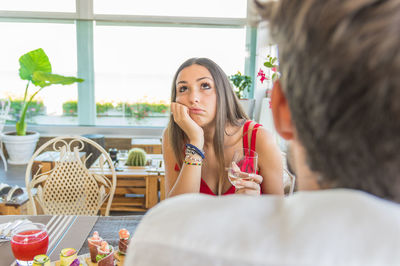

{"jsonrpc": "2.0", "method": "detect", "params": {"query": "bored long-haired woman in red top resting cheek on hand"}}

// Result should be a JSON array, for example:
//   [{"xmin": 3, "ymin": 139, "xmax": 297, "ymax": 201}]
[{"xmin": 163, "ymin": 58, "xmax": 283, "ymax": 197}]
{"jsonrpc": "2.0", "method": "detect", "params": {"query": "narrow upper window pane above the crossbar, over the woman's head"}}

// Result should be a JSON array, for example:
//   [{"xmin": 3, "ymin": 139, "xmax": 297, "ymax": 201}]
[{"xmin": 93, "ymin": 0, "xmax": 247, "ymax": 18}]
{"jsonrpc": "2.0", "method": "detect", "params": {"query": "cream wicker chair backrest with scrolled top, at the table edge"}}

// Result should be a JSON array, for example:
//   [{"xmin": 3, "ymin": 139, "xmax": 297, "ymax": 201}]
[{"xmin": 25, "ymin": 136, "xmax": 116, "ymax": 215}]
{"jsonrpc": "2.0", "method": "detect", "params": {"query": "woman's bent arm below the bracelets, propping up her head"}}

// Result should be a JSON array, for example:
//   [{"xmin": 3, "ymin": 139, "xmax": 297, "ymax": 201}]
[{"xmin": 162, "ymin": 130, "xmax": 201, "ymax": 197}]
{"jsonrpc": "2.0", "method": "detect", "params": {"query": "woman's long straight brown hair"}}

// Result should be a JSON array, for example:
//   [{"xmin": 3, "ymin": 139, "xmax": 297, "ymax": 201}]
[{"xmin": 167, "ymin": 58, "xmax": 248, "ymax": 195}]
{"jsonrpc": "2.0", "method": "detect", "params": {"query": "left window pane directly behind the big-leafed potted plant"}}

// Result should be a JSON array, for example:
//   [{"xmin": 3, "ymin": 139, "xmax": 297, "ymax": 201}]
[{"xmin": 0, "ymin": 22, "xmax": 78, "ymax": 125}]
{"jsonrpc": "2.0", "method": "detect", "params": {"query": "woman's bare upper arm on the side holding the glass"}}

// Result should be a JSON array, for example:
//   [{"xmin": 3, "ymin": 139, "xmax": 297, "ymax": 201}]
[{"xmin": 256, "ymin": 127, "xmax": 284, "ymax": 194}]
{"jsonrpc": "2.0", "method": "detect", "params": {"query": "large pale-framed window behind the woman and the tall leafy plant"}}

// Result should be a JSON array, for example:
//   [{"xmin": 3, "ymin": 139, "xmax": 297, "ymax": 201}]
[{"xmin": 0, "ymin": 0, "xmax": 255, "ymax": 131}]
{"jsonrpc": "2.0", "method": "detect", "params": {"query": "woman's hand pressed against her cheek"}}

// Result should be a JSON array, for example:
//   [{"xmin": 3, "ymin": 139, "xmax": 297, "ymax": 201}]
[{"xmin": 171, "ymin": 102, "xmax": 204, "ymax": 149}]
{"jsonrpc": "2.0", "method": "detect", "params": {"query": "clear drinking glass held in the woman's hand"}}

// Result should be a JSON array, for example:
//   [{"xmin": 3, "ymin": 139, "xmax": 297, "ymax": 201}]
[{"xmin": 228, "ymin": 149, "xmax": 258, "ymax": 189}]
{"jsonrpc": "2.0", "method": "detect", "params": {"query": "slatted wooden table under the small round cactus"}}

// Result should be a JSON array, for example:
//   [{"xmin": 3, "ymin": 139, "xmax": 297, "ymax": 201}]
[{"xmin": 89, "ymin": 155, "xmax": 165, "ymax": 212}]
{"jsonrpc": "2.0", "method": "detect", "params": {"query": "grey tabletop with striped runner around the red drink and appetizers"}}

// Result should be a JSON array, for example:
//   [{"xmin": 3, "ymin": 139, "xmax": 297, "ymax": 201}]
[{"xmin": 0, "ymin": 215, "xmax": 142, "ymax": 265}]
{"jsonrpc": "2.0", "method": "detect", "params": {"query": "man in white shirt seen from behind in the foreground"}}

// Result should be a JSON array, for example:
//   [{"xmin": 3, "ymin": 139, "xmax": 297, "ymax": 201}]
[{"xmin": 127, "ymin": 0, "xmax": 400, "ymax": 266}]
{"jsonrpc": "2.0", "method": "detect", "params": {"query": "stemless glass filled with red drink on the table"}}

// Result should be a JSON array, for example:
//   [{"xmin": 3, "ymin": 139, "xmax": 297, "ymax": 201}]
[{"xmin": 11, "ymin": 223, "xmax": 49, "ymax": 265}]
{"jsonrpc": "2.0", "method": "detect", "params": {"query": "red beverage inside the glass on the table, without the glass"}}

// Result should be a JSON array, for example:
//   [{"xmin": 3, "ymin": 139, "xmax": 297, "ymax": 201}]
[{"xmin": 11, "ymin": 229, "xmax": 49, "ymax": 261}]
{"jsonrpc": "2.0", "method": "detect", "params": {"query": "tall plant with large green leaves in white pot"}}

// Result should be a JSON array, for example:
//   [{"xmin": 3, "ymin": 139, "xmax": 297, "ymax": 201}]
[{"xmin": 1, "ymin": 48, "xmax": 83, "ymax": 164}]
